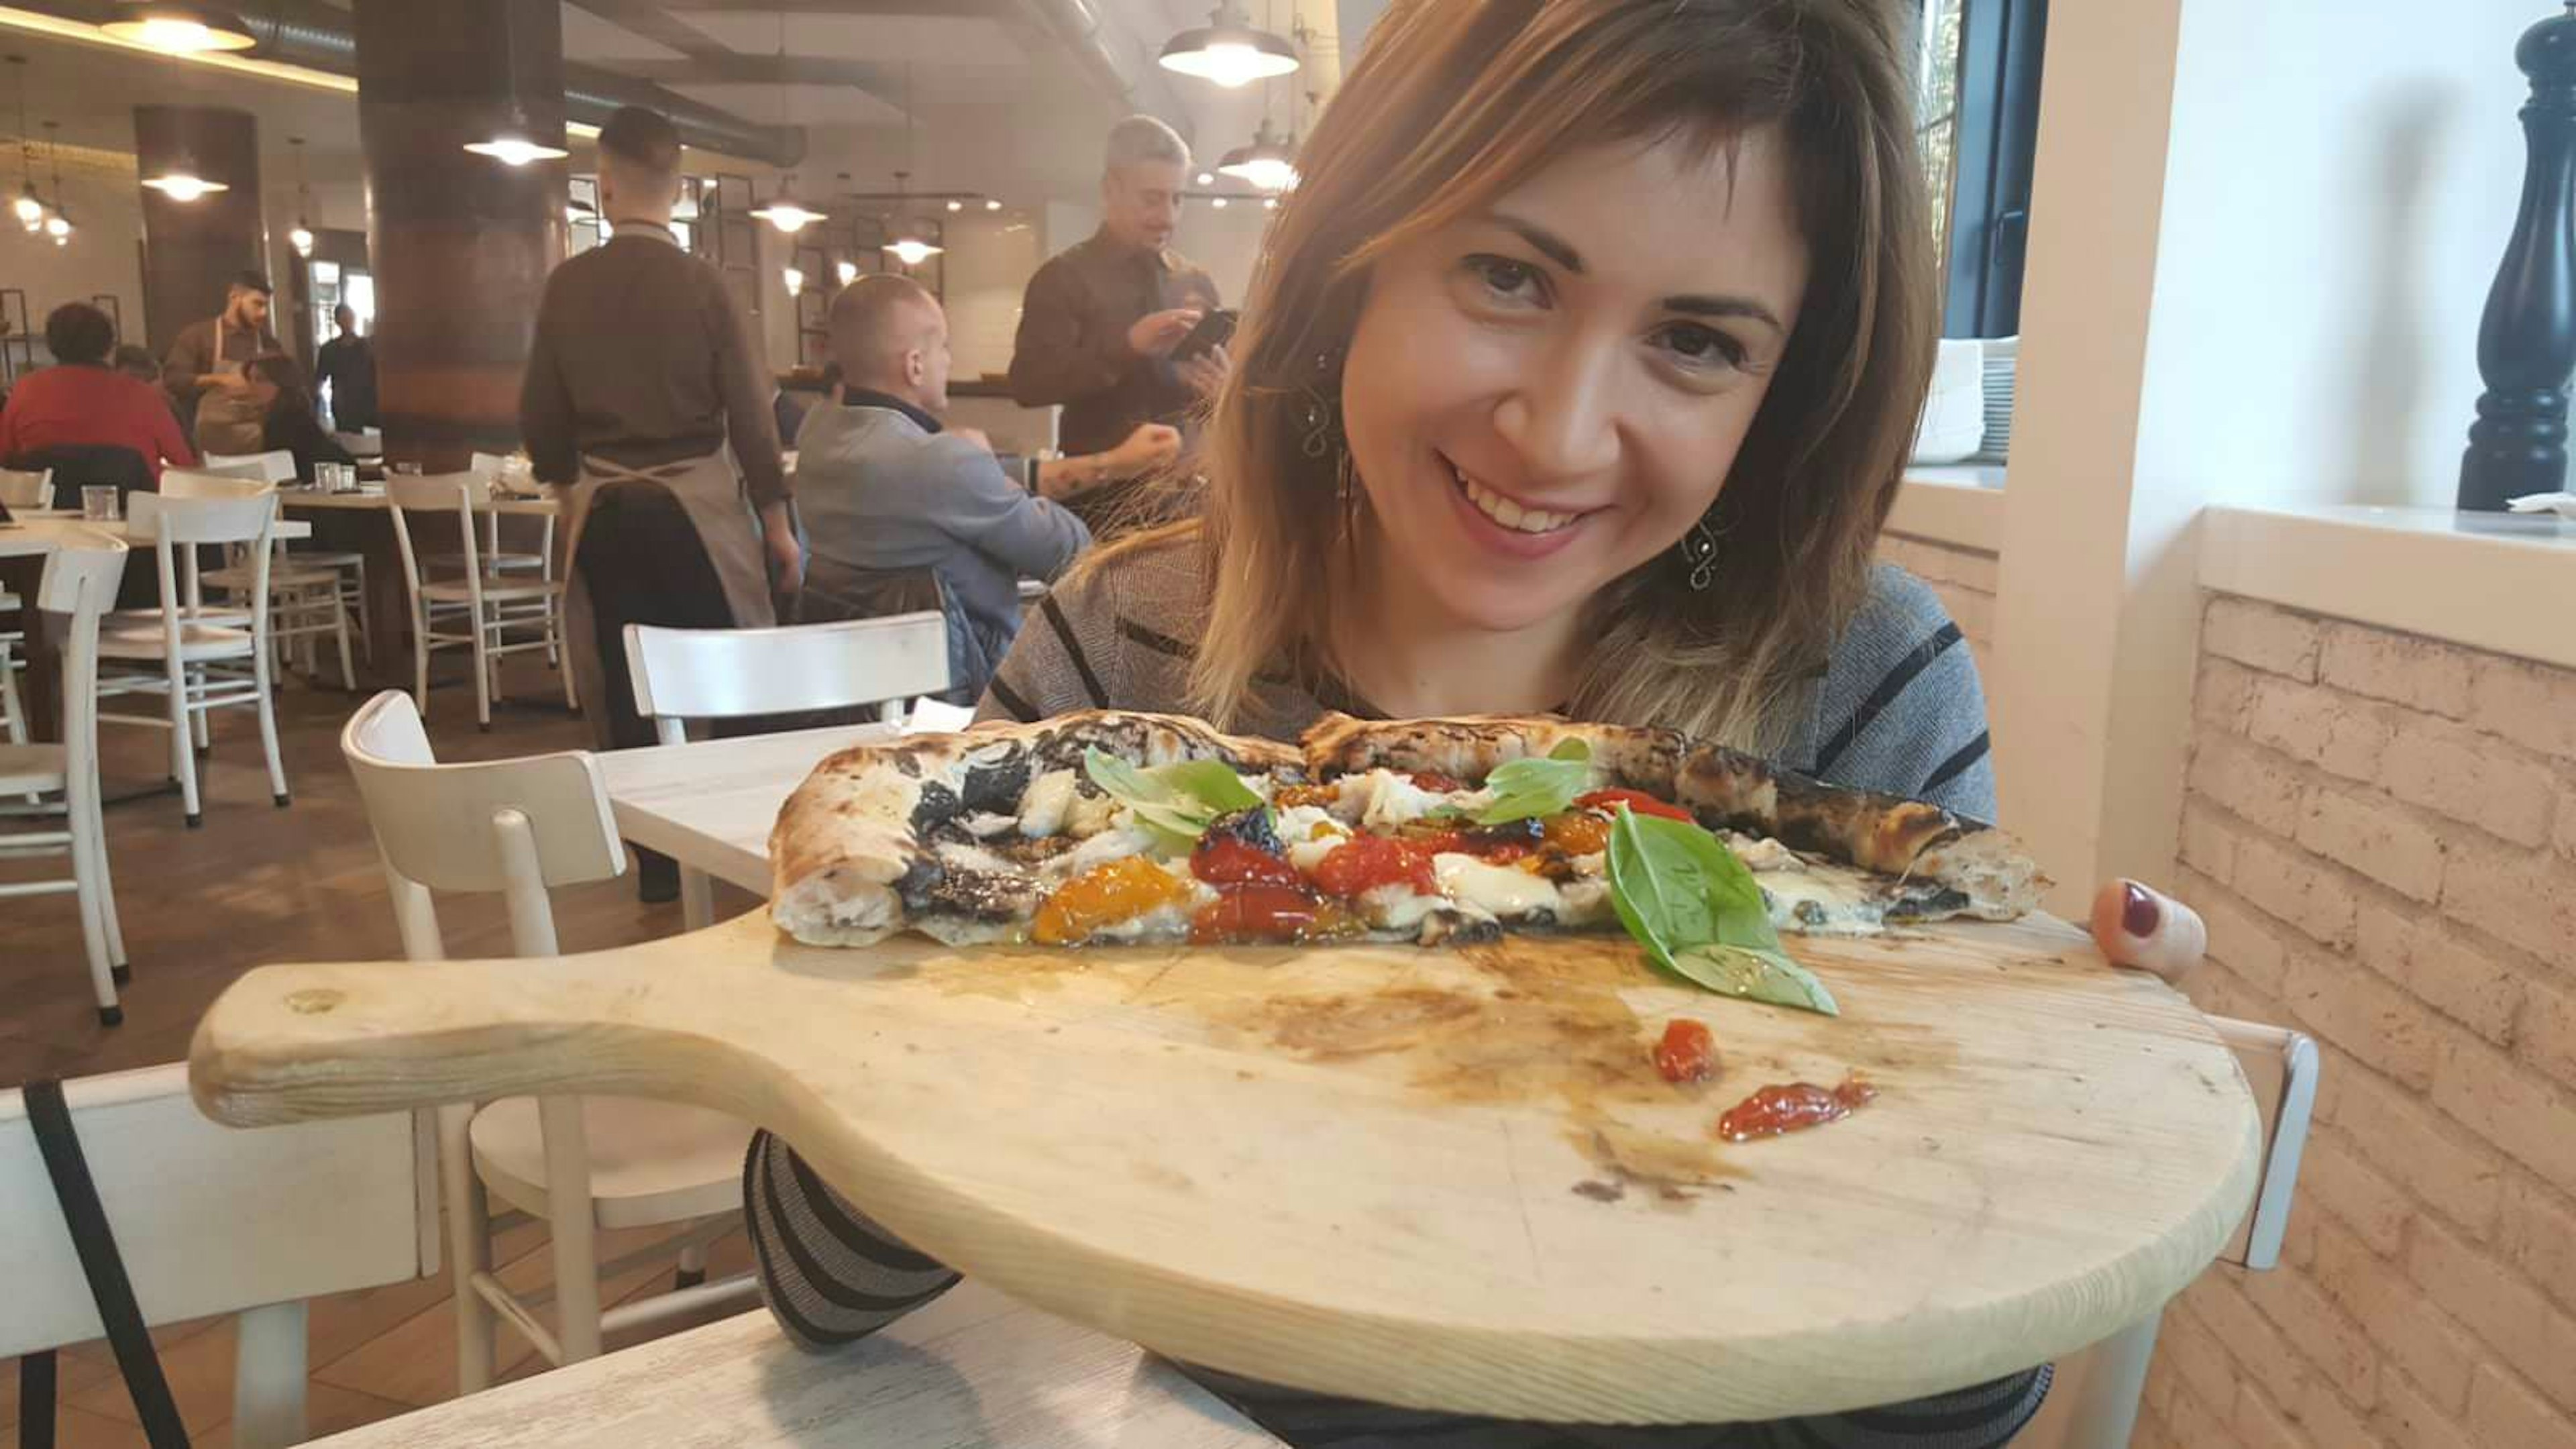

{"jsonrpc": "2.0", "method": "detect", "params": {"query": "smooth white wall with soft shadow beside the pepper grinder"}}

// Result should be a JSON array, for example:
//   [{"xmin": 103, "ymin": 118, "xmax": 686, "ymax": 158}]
[{"xmin": 2143, "ymin": 0, "xmax": 2548, "ymax": 508}]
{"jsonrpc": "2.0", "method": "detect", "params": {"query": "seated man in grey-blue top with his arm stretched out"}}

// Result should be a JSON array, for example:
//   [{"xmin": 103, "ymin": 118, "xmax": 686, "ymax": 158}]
[{"xmin": 796, "ymin": 273, "xmax": 1180, "ymax": 704}]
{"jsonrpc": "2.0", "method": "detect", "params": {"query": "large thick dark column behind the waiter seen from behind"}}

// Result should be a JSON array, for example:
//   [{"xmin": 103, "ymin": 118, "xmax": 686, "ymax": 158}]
[{"xmin": 358, "ymin": 0, "xmax": 564, "ymax": 472}]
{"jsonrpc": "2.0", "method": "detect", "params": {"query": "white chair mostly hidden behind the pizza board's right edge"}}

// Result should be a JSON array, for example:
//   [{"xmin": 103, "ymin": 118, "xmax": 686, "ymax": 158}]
[{"xmin": 2015, "ymin": 1016, "xmax": 2318, "ymax": 1449}]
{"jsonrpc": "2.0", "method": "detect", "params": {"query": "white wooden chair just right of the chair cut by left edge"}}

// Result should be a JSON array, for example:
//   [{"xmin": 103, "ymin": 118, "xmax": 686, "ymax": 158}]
[{"xmin": 98, "ymin": 487, "xmax": 288, "ymax": 828}]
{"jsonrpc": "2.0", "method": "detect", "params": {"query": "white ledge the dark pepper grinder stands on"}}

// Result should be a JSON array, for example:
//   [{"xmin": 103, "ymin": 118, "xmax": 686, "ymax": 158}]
[{"xmin": 2200, "ymin": 505, "xmax": 2576, "ymax": 667}]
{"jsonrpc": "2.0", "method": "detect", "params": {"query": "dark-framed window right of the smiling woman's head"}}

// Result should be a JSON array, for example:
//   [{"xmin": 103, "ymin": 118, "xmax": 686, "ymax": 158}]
[{"xmin": 1917, "ymin": 0, "xmax": 2048, "ymax": 337}]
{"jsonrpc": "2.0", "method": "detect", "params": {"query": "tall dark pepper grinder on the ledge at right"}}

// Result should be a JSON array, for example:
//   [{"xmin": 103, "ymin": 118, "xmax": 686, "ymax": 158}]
[{"xmin": 2460, "ymin": 0, "xmax": 2576, "ymax": 513}]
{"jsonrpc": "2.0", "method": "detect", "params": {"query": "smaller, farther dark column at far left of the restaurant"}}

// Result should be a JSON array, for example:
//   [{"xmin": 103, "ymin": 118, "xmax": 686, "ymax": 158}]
[{"xmin": 123, "ymin": 106, "xmax": 268, "ymax": 356}]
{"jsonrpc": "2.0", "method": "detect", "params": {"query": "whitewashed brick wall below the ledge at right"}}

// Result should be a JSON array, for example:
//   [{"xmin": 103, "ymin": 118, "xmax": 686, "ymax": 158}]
[{"xmin": 2135, "ymin": 596, "xmax": 2576, "ymax": 1449}]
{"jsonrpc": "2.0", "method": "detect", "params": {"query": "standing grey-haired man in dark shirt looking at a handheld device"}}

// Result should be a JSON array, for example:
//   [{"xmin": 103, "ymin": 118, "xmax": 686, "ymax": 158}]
[{"xmin": 1010, "ymin": 116, "xmax": 1229, "ymax": 529}]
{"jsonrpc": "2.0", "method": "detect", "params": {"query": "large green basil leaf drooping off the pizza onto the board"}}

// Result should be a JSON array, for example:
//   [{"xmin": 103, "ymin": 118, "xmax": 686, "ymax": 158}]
[{"xmin": 1607, "ymin": 807, "xmax": 1842, "ymax": 1016}]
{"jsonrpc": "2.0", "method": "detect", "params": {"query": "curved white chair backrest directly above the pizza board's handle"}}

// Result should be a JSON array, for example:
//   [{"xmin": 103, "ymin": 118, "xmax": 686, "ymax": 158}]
[{"xmin": 340, "ymin": 688, "xmax": 626, "ymax": 959}]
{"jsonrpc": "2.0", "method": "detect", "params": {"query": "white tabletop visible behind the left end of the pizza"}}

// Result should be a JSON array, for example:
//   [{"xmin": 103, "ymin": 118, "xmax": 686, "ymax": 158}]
[{"xmin": 600, "ymin": 724, "xmax": 896, "ymax": 895}]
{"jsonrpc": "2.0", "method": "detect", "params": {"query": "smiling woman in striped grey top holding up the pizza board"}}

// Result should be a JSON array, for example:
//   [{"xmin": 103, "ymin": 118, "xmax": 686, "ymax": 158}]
[{"xmin": 747, "ymin": 0, "xmax": 2061, "ymax": 1449}]
